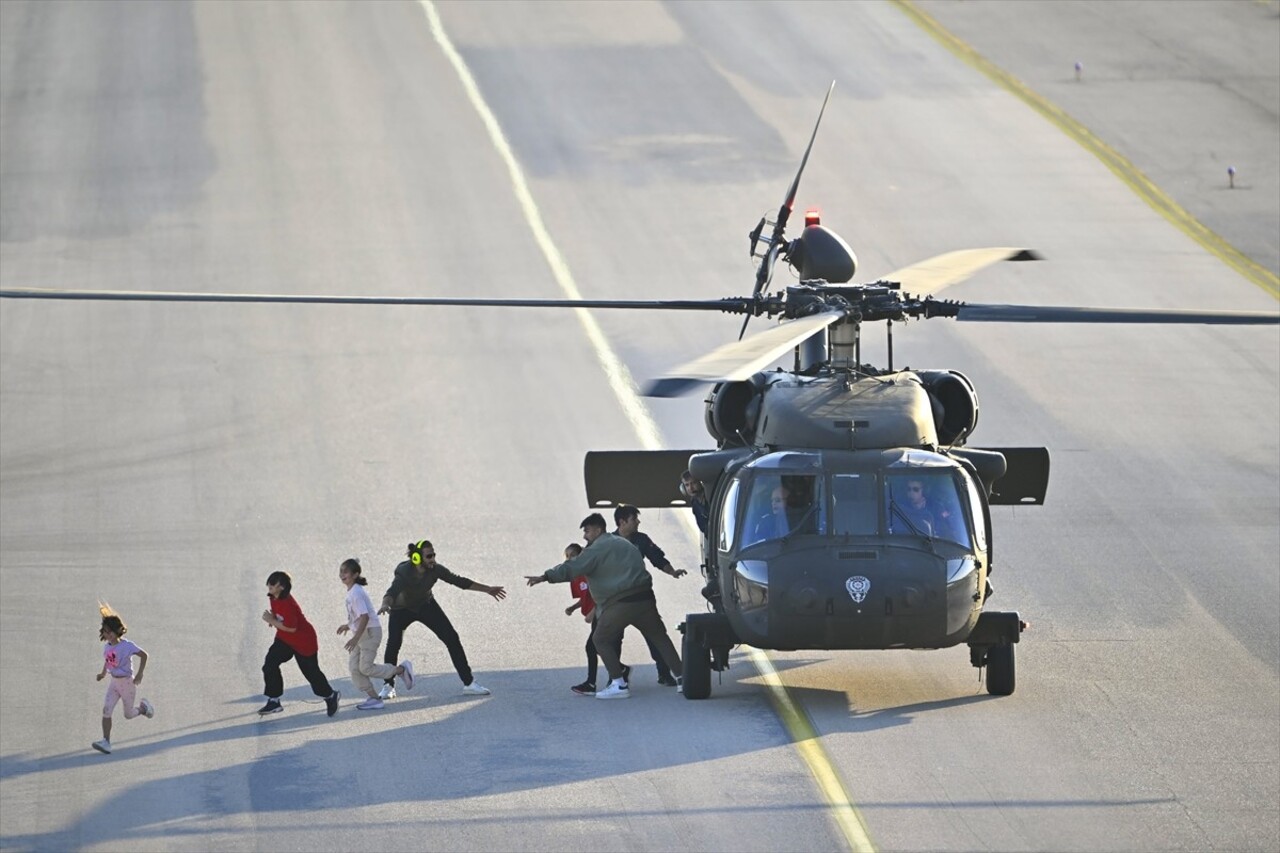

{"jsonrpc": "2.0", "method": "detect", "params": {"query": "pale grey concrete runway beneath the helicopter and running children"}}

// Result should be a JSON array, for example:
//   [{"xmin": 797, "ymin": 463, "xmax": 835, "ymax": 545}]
[{"xmin": 0, "ymin": 1, "xmax": 1280, "ymax": 850}]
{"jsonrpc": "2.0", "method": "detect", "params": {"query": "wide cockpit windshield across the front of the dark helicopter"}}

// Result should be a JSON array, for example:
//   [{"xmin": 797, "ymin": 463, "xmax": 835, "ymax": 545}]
[{"xmin": 718, "ymin": 451, "xmax": 986, "ymax": 553}]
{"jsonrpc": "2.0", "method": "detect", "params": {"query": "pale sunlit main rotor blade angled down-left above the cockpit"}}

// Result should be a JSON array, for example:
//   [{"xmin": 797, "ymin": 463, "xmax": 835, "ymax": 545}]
[{"xmin": 643, "ymin": 310, "xmax": 845, "ymax": 397}]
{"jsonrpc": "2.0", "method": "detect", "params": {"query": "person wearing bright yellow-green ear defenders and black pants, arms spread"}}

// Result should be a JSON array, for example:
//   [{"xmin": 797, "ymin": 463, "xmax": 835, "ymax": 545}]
[{"xmin": 378, "ymin": 539, "xmax": 507, "ymax": 699}]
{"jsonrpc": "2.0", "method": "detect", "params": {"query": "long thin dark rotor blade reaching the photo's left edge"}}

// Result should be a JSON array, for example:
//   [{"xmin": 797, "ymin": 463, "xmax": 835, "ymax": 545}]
[{"xmin": 0, "ymin": 288, "xmax": 750, "ymax": 314}]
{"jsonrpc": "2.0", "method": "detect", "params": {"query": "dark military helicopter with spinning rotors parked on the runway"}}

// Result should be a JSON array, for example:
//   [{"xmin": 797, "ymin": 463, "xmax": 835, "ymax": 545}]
[{"xmin": 0, "ymin": 83, "xmax": 1280, "ymax": 699}]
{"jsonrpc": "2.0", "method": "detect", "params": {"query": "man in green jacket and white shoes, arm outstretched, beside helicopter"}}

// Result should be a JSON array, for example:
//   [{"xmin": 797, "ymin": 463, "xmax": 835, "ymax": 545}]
[{"xmin": 525, "ymin": 512, "xmax": 684, "ymax": 699}]
